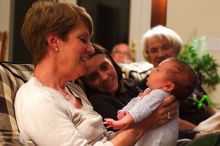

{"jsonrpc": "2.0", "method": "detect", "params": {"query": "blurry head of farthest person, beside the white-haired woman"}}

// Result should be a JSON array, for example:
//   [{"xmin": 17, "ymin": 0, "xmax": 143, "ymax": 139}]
[{"xmin": 111, "ymin": 43, "xmax": 133, "ymax": 63}]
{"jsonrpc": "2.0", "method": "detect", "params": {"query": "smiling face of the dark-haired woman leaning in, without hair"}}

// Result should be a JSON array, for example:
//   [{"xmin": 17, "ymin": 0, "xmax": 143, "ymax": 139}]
[{"xmin": 83, "ymin": 54, "xmax": 118, "ymax": 93}]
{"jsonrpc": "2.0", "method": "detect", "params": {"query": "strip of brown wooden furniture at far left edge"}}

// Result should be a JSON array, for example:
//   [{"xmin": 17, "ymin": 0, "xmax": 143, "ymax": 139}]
[{"xmin": 0, "ymin": 31, "xmax": 7, "ymax": 61}]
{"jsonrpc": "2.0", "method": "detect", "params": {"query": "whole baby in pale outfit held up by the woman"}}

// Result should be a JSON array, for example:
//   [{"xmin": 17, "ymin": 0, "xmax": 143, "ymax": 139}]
[{"xmin": 104, "ymin": 58, "xmax": 197, "ymax": 146}]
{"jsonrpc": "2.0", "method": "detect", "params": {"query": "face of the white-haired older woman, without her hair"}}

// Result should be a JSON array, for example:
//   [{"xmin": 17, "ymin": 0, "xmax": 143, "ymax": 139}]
[{"xmin": 148, "ymin": 37, "xmax": 178, "ymax": 67}]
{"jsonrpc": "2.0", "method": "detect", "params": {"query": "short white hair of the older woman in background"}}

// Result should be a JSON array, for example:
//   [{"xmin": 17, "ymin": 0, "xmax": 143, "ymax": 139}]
[{"xmin": 141, "ymin": 25, "xmax": 182, "ymax": 60}]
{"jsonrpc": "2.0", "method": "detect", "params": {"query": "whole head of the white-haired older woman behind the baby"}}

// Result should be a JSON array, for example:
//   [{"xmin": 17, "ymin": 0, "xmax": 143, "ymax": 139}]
[{"xmin": 142, "ymin": 25, "xmax": 182, "ymax": 67}]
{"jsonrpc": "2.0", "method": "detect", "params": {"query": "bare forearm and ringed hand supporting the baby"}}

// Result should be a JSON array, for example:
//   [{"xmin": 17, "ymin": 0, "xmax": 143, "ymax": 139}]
[{"xmin": 111, "ymin": 96, "xmax": 178, "ymax": 146}]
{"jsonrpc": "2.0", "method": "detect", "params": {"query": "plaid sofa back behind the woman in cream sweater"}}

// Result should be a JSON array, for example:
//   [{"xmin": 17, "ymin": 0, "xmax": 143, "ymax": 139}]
[{"xmin": 0, "ymin": 62, "xmax": 34, "ymax": 145}]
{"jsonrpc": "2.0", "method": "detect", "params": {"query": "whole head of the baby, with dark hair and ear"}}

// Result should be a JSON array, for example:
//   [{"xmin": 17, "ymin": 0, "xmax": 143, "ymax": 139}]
[{"xmin": 147, "ymin": 58, "xmax": 197, "ymax": 101}]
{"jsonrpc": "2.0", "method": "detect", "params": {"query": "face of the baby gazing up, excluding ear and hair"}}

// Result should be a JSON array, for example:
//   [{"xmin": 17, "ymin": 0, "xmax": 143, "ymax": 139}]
[{"xmin": 146, "ymin": 59, "xmax": 173, "ymax": 90}]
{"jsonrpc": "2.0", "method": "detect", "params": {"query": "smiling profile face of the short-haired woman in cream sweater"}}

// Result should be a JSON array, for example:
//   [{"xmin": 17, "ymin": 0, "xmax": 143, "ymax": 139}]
[{"xmin": 57, "ymin": 22, "xmax": 94, "ymax": 80}]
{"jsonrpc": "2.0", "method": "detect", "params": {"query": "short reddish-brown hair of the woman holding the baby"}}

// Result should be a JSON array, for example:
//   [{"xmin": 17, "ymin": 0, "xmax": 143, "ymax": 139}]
[{"xmin": 21, "ymin": 1, "xmax": 93, "ymax": 65}]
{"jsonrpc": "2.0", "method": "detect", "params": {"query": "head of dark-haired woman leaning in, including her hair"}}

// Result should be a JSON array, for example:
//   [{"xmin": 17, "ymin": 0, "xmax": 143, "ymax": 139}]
[{"xmin": 83, "ymin": 44, "xmax": 122, "ymax": 93}]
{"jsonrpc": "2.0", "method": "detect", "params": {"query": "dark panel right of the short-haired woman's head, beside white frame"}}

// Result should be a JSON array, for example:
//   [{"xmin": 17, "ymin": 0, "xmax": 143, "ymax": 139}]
[{"xmin": 78, "ymin": 0, "xmax": 130, "ymax": 51}]
